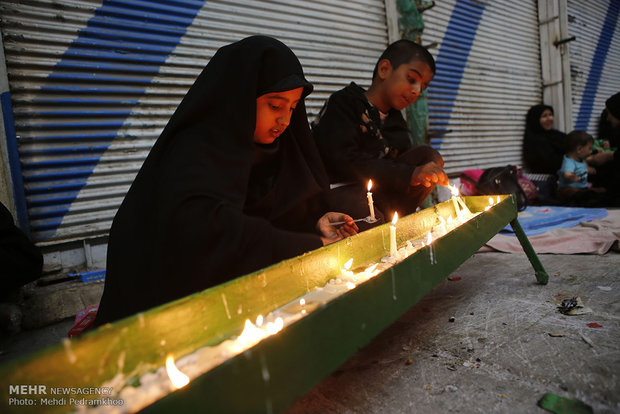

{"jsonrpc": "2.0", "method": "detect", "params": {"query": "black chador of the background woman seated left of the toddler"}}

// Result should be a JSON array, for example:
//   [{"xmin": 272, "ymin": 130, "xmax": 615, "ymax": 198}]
[{"xmin": 523, "ymin": 105, "xmax": 566, "ymax": 174}]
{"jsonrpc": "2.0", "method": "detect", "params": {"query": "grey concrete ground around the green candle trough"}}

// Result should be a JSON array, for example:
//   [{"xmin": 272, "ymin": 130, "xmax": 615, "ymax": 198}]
[{"xmin": 0, "ymin": 252, "xmax": 620, "ymax": 414}]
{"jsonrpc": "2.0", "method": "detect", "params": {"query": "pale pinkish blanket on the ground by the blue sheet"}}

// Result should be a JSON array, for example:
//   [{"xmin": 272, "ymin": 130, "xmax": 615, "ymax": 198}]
[{"xmin": 480, "ymin": 209, "xmax": 620, "ymax": 254}]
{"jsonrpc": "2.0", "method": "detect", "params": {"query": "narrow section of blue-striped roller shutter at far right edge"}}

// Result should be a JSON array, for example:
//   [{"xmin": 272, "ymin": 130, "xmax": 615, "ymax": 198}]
[{"xmin": 568, "ymin": 0, "xmax": 620, "ymax": 137}]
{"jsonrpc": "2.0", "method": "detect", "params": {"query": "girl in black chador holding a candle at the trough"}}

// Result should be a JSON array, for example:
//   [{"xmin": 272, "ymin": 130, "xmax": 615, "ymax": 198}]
[{"xmin": 95, "ymin": 36, "xmax": 358, "ymax": 325}]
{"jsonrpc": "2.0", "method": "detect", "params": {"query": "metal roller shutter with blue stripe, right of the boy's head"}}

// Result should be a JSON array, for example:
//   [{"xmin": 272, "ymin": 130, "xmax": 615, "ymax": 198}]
[{"xmin": 423, "ymin": 0, "xmax": 542, "ymax": 175}]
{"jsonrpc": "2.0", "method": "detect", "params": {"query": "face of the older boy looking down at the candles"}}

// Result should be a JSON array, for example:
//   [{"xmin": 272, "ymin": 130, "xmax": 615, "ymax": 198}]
[{"xmin": 378, "ymin": 59, "xmax": 435, "ymax": 111}]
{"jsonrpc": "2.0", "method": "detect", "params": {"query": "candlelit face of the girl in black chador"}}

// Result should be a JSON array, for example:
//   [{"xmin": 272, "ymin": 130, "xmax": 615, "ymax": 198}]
[{"xmin": 254, "ymin": 87, "xmax": 303, "ymax": 144}]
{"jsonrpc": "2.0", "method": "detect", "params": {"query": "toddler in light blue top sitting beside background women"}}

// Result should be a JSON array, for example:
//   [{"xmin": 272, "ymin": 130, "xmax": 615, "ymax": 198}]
[{"xmin": 557, "ymin": 131, "xmax": 604, "ymax": 202}]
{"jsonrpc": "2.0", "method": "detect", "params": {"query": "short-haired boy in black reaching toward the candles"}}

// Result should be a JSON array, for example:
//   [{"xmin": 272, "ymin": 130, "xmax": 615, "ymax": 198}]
[{"xmin": 312, "ymin": 39, "xmax": 448, "ymax": 219}]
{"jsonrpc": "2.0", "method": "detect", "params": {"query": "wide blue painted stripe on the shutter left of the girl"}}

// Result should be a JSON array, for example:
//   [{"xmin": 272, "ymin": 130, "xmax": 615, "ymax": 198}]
[{"xmin": 23, "ymin": 0, "xmax": 204, "ymax": 240}]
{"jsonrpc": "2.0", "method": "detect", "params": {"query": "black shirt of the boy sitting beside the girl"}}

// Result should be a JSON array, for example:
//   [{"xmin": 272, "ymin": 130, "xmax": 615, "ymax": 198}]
[{"xmin": 312, "ymin": 82, "xmax": 415, "ymax": 196}]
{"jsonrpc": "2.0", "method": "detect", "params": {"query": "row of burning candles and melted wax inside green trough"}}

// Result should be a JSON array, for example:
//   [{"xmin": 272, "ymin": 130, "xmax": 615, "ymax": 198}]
[{"xmin": 95, "ymin": 194, "xmax": 500, "ymax": 412}]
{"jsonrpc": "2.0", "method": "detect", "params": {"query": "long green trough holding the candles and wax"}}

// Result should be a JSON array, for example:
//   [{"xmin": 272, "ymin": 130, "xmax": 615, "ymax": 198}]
[{"xmin": 0, "ymin": 196, "xmax": 516, "ymax": 413}]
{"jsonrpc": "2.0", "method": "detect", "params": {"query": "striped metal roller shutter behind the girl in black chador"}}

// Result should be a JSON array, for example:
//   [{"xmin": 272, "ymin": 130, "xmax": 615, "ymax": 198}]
[{"xmin": 0, "ymin": 0, "xmax": 388, "ymax": 245}]
